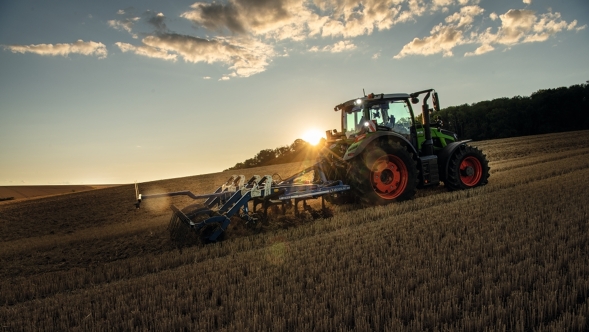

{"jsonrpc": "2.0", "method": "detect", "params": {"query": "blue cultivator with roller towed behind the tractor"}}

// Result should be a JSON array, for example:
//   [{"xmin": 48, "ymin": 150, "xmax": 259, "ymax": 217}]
[{"xmin": 135, "ymin": 167, "xmax": 350, "ymax": 243}]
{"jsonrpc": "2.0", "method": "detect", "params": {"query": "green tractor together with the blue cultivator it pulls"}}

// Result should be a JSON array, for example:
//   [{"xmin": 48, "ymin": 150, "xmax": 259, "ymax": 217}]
[{"xmin": 135, "ymin": 89, "xmax": 489, "ymax": 243}]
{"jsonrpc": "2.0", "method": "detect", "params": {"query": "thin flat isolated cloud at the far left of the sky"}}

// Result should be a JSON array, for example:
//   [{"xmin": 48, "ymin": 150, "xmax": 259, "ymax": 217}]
[{"xmin": 4, "ymin": 39, "xmax": 108, "ymax": 59}]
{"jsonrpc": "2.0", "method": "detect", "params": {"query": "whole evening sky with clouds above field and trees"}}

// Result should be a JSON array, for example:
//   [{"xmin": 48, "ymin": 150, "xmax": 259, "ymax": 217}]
[{"xmin": 0, "ymin": 0, "xmax": 589, "ymax": 185}]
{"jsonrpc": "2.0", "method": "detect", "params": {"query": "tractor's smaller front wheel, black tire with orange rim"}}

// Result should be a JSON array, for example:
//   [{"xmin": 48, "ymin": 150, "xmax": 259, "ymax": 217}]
[{"xmin": 444, "ymin": 144, "xmax": 490, "ymax": 190}]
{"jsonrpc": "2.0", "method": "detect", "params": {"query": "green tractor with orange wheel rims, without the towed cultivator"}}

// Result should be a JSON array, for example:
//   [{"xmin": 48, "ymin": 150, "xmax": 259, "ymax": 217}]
[{"xmin": 322, "ymin": 89, "xmax": 489, "ymax": 205}]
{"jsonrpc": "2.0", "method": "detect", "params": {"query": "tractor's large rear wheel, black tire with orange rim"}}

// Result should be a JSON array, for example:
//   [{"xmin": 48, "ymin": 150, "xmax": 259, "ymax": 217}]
[{"xmin": 348, "ymin": 141, "xmax": 418, "ymax": 206}]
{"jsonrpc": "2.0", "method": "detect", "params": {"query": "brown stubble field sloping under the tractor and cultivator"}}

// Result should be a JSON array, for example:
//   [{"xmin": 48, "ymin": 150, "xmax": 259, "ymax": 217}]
[{"xmin": 0, "ymin": 131, "xmax": 589, "ymax": 331}]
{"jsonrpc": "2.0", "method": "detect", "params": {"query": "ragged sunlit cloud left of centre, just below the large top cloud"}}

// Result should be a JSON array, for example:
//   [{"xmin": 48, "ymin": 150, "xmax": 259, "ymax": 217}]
[{"xmin": 116, "ymin": 33, "xmax": 274, "ymax": 77}]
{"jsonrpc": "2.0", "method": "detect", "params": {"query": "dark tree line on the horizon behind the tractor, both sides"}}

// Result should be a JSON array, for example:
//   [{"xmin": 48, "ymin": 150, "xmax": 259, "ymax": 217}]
[{"xmin": 226, "ymin": 81, "xmax": 589, "ymax": 171}]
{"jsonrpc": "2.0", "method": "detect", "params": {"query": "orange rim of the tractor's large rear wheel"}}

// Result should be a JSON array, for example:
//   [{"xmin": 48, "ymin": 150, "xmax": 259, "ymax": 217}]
[{"xmin": 370, "ymin": 154, "xmax": 409, "ymax": 199}]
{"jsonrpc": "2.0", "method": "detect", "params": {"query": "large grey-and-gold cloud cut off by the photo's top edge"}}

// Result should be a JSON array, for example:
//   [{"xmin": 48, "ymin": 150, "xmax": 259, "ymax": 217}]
[{"xmin": 181, "ymin": 0, "xmax": 444, "ymax": 40}]
